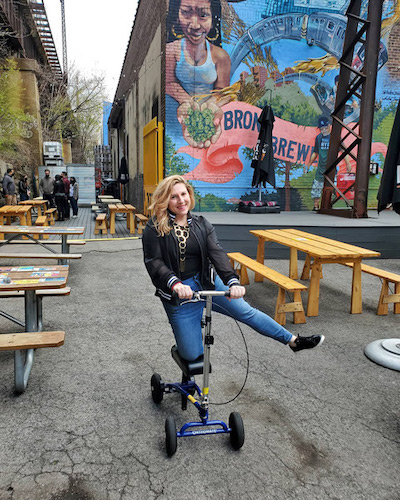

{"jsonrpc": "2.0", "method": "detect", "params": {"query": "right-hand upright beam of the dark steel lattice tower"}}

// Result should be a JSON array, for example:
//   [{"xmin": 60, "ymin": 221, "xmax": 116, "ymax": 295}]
[{"xmin": 354, "ymin": 0, "xmax": 383, "ymax": 218}]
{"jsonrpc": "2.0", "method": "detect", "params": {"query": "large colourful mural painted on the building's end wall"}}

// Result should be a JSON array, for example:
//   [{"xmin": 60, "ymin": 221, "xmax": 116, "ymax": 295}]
[{"xmin": 165, "ymin": 0, "xmax": 400, "ymax": 211}]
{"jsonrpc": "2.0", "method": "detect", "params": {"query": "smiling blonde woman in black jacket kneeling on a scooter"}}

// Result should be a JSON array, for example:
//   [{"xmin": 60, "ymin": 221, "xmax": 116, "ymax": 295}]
[{"xmin": 143, "ymin": 175, "xmax": 324, "ymax": 361}]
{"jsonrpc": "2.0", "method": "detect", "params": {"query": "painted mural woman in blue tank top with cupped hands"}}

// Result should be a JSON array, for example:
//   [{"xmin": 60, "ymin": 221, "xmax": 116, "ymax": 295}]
[{"xmin": 166, "ymin": 0, "xmax": 231, "ymax": 148}]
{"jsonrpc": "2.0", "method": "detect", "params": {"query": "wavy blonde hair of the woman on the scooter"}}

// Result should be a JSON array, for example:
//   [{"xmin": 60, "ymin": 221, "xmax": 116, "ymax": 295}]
[{"xmin": 149, "ymin": 175, "xmax": 195, "ymax": 236}]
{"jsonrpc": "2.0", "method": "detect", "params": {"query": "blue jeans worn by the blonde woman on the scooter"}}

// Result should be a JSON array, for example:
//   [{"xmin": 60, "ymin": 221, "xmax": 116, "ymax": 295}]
[{"xmin": 162, "ymin": 276, "xmax": 292, "ymax": 361}]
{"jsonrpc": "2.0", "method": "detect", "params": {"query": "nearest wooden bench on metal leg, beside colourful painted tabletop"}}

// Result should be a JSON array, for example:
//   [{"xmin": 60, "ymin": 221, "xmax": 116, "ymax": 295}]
[{"xmin": 0, "ymin": 331, "xmax": 65, "ymax": 394}]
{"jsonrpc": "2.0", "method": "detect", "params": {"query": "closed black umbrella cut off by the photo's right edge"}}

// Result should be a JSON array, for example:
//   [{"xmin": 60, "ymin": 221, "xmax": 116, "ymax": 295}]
[{"xmin": 378, "ymin": 101, "xmax": 400, "ymax": 215}]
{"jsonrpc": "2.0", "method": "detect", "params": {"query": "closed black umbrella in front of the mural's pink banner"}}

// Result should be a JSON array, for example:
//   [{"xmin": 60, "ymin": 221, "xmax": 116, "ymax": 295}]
[{"xmin": 251, "ymin": 104, "xmax": 275, "ymax": 201}]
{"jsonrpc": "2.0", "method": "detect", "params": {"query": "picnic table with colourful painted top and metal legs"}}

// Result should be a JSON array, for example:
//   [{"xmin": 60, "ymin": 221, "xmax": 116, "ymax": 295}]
[{"xmin": 0, "ymin": 266, "xmax": 69, "ymax": 393}]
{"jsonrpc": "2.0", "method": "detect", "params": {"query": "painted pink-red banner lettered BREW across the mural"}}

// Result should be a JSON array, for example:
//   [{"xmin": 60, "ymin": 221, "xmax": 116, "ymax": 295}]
[{"xmin": 177, "ymin": 102, "xmax": 387, "ymax": 184}]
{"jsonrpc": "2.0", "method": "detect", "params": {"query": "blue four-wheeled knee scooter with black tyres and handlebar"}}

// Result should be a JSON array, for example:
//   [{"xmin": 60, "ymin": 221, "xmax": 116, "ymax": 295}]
[{"xmin": 151, "ymin": 291, "xmax": 244, "ymax": 457}]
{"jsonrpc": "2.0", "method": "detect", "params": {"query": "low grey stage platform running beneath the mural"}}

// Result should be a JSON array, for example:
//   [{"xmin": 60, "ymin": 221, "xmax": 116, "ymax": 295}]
[{"xmin": 196, "ymin": 210, "xmax": 400, "ymax": 259}]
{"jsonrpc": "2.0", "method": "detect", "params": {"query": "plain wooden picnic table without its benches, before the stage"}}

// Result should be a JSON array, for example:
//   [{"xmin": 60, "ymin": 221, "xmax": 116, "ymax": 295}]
[{"xmin": 250, "ymin": 229, "xmax": 380, "ymax": 316}]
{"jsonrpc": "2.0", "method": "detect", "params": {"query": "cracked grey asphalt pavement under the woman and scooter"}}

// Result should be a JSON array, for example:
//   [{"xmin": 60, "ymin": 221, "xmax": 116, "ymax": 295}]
[{"xmin": 0, "ymin": 240, "xmax": 400, "ymax": 500}]
